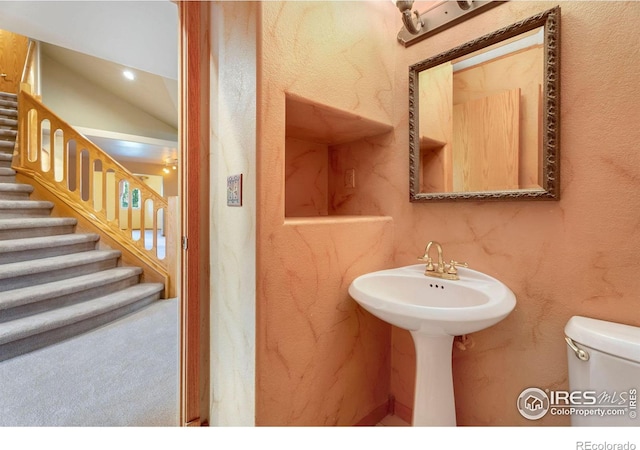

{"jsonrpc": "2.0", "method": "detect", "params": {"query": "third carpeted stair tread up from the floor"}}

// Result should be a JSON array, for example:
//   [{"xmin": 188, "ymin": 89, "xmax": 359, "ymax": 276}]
[{"xmin": 0, "ymin": 250, "xmax": 120, "ymax": 284}]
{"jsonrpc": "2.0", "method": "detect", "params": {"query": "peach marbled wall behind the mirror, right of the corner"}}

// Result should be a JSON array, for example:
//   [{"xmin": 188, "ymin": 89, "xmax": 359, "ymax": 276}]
[{"xmin": 391, "ymin": 2, "xmax": 640, "ymax": 425}]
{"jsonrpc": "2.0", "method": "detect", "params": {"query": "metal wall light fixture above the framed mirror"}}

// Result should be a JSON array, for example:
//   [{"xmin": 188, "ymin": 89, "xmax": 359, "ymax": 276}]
[{"xmin": 391, "ymin": 0, "xmax": 506, "ymax": 47}]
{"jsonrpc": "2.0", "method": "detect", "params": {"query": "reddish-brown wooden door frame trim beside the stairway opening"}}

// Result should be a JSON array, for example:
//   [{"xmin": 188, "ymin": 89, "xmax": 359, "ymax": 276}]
[{"xmin": 176, "ymin": 1, "xmax": 211, "ymax": 426}]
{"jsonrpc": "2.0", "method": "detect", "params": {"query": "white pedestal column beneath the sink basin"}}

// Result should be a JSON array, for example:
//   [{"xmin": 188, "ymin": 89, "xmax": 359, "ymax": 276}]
[{"xmin": 411, "ymin": 331, "xmax": 456, "ymax": 427}]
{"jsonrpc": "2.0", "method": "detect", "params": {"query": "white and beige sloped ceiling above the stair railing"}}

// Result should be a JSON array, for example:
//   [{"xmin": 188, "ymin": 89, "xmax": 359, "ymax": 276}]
[{"xmin": 0, "ymin": 0, "xmax": 178, "ymax": 163}]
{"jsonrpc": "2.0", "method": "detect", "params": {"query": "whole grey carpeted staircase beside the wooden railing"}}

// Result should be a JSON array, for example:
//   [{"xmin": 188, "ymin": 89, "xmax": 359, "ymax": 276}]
[{"xmin": 0, "ymin": 93, "xmax": 164, "ymax": 361}]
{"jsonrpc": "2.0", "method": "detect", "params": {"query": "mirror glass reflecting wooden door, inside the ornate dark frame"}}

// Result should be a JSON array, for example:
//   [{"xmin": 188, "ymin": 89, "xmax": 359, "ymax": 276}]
[{"xmin": 418, "ymin": 27, "xmax": 544, "ymax": 193}]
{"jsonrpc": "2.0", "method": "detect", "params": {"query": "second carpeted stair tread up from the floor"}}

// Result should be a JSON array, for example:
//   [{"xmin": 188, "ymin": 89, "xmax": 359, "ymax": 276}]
[{"xmin": 0, "ymin": 267, "xmax": 142, "ymax": 311}]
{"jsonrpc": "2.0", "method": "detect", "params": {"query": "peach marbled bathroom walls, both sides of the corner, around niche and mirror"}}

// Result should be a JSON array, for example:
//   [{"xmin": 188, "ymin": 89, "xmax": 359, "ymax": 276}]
[{"xmin": 256, "ymin": 1, "xmax": 640, "ymax": 425}]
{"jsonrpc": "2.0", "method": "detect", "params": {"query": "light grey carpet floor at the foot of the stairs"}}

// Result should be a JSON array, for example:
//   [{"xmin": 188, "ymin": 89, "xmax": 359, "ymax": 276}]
[{"xmin": 0, "ymin": 299, "xmax": 179, "ymax": 427}]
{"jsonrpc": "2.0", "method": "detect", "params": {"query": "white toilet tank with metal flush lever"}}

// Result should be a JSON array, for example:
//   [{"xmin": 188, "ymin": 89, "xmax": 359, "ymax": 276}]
[{"xmin": 564, "ymin": 316, "xmax": 640, "ymax": 426}]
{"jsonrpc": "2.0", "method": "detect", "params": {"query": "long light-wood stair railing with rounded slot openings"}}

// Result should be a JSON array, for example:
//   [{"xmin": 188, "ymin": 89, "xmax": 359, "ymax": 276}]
[{"xmin": 13, "ymin": 90, "xmax": 169, "ymax": 293}]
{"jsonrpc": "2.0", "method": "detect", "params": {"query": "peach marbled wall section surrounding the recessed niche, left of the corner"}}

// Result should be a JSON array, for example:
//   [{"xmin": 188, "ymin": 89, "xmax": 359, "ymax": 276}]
[{"xmin": 256, "ymin": 2, "xmax": 395, "ymax": 425}]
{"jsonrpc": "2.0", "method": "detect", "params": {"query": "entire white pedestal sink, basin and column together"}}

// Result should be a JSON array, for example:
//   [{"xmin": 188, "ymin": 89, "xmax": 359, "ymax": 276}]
[{"xmin": 349, "ymin": 264, "xmax": 516, "ymax": 426}]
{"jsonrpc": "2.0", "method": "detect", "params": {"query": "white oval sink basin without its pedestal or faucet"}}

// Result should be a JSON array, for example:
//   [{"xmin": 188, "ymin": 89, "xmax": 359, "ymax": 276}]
[{"xmin": 349, "ymin": 264, "xmax": 516, "ymax": 336}]
